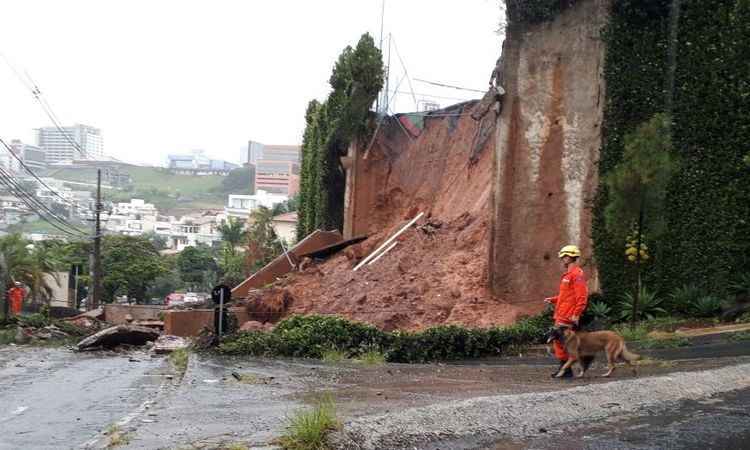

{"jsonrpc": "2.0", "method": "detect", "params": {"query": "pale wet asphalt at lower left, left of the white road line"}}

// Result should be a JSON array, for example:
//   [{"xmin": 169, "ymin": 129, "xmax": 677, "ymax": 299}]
[{"xmin": 0, "ymin": 346, "xmax": 165, "ymax": 450}]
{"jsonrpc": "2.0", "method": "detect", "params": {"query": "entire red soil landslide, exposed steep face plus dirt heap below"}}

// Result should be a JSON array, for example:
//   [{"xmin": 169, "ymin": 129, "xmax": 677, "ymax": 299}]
[{"xmin": 247, "ymin": 103, "xmax": 541, "ymax": 330}]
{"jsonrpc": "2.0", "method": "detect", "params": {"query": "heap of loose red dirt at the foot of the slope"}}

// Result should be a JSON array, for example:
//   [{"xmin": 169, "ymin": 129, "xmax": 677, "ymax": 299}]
[{"xmin": 284, "ymin": 213, "xmax": 532, "ymax": 330}]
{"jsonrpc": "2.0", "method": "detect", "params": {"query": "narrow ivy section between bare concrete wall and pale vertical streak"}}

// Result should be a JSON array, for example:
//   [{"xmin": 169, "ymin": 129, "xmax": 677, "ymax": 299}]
[{"xmin": 592, "ymin": 0, "xmax": 671, "ymax": 298}]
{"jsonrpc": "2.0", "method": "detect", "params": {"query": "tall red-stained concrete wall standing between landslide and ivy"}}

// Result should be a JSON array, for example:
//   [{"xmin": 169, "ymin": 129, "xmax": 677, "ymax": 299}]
[{"xmin": 489, "ymin": 0, "xmax": 609, "ymax": 308}]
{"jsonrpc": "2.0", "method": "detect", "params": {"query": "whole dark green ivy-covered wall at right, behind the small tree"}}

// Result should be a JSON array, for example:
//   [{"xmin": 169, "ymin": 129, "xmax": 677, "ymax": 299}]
[{"xmin": 593, "ymin": 0, "xmax": 750, "ymax": 296}]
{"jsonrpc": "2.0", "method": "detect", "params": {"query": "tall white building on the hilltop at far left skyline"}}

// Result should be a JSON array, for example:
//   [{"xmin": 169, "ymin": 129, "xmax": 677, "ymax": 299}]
[{"xmin": 36, "ymin": 124, "xmax": 104, "ymax": 164}]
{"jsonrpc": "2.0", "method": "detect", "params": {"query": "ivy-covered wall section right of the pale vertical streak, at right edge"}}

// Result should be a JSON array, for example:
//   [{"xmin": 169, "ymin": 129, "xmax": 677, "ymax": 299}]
[{"xmin": 661, "ymin": 0, "xmax": 750, "ymax": 293}]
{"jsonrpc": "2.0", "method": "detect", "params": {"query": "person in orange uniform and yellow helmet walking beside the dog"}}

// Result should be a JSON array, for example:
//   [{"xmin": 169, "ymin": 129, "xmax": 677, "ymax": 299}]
[{"xmin": 544, "ymin": 245, "xmax": 591, "ymax": 378}]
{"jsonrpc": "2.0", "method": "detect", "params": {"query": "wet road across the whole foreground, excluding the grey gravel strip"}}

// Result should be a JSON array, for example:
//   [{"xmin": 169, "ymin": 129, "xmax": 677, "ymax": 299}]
[{"xmin": 0, "ymin": 343, "xmax": 750, "ymax": 450}]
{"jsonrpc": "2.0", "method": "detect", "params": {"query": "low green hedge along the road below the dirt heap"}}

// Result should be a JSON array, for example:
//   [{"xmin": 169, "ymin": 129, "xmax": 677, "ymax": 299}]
[{"xmin": 219, "ymin": 314, "xmax": 552, "ymax": 363}]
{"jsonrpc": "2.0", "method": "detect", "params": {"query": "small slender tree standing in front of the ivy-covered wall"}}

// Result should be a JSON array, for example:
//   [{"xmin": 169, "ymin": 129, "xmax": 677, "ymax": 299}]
[{"xmin": 604, "ymin": 114, "xmax": 679, "ymax": 326}]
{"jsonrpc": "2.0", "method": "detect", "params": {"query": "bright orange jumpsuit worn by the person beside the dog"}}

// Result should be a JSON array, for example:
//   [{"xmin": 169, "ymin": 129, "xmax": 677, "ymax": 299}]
[{"xmin": 550, "ymin": 264, "xmax": 588, "ymax": 361}]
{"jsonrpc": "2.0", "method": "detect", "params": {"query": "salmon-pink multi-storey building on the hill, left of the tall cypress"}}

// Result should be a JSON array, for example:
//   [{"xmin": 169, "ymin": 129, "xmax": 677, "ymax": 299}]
[{"xmin": 242, "ymin": 141, "xmax": 301, "ymax": 197}]
